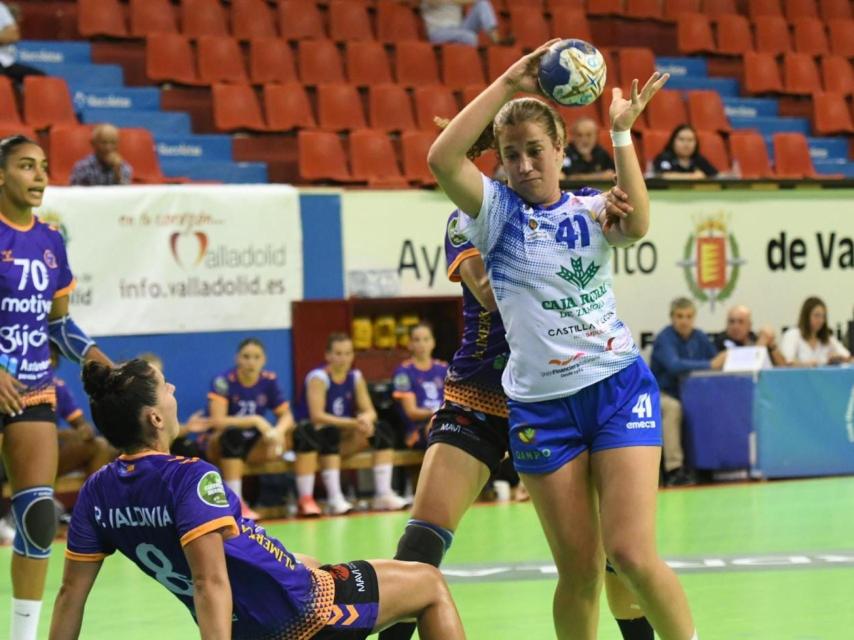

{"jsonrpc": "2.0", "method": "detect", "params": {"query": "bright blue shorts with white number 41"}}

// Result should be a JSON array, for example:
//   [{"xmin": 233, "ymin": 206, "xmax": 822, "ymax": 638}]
[{"xmin": 507, "ymin": 358, "xmax": 661, "ymax": 474}]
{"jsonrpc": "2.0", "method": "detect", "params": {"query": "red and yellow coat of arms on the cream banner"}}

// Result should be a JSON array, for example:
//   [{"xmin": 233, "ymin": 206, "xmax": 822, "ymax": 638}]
[{"xmin": 677, "ymin": 212, "xmax": 747, "ymax": 309}]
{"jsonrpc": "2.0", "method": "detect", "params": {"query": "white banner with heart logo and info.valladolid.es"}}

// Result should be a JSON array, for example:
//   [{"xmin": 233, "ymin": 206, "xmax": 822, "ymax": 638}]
[{"xmin": 36, "ymin": 185, "xmax": 303, "ymax": 336}]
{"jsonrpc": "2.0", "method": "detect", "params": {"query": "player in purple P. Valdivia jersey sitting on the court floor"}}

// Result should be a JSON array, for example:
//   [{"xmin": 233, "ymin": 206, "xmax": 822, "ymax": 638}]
[{"xmin": 50, "ymin": 359, "xmax": 465, "ymax": 640}]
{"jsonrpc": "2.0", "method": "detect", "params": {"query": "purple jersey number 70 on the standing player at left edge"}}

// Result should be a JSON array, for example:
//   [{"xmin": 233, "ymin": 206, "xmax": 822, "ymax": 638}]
[{"xmin": 0, "ymin": 214, "xmax": 74, "ymax": 390}]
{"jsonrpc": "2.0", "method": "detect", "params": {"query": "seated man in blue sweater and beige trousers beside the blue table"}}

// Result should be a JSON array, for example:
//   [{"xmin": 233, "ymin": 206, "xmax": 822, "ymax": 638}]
[{"xmin": 650, "ymin": 298, "xmax": 726, "ymax": 486}]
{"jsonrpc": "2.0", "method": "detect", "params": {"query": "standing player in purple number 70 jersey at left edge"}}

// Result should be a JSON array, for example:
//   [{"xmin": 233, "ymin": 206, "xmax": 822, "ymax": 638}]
[{"xmin": 0, "ymin": 136, "xmax": 109, "ymax": 640}]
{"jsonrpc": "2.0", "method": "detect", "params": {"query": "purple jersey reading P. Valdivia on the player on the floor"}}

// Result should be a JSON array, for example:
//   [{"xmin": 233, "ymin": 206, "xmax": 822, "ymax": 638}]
[{"xmin": 65, "ymin": 452, "xmax": 334, "ymax": 640}]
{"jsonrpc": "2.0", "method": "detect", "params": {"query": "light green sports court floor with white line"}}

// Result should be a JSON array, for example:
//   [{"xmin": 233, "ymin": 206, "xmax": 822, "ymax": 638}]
[{"xmin": 0, "ymin": 478, "xmax": 854, "ymax": 640}]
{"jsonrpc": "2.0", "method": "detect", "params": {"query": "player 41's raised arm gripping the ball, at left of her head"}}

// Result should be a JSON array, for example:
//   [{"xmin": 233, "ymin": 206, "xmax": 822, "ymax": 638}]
[{"xmin": 427, "ymin": 40, "xmax": 556, "ymax": 218}]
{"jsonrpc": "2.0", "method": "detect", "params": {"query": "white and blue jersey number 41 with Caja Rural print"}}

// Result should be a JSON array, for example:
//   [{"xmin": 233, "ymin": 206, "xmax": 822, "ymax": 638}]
[{"xmin": 459, "ymin": 176, "xmax": 640, "ymax": 402}]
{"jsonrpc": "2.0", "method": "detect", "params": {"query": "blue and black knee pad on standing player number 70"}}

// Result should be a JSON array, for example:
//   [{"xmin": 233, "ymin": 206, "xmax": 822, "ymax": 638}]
[{"xmin": 12, "ymin": 487, "xmax": 58, "ymax": 559}]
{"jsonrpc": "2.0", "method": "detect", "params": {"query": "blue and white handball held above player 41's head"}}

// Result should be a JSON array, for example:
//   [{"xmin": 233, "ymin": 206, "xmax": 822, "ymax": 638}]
[{"xmin": 539, "ymin": 40, "xmax": 607, "ymax": 107}]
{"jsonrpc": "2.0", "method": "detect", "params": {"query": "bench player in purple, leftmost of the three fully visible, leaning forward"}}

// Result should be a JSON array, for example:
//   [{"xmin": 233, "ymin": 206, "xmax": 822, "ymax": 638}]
[{"xmin": 208, "ymin": 338, "xmax": 320, "ymax": 520}]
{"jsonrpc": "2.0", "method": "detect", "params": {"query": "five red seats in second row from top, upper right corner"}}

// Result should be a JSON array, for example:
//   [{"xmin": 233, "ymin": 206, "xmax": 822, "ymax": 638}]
[{"xmin": 676, "ymin": 14, "xmax": 854, "ymax": 57}]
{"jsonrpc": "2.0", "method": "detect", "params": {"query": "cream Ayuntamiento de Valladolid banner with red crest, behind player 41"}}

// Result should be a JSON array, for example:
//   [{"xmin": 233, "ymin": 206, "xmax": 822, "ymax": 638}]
[{"xmin": 342, "ymin": 190, "xmax": 854, "ymax": 346}]
